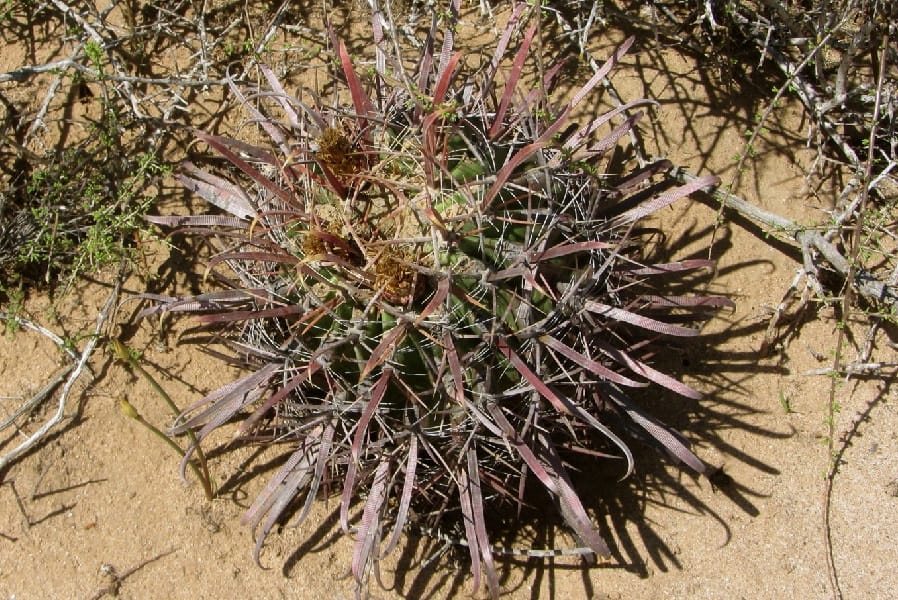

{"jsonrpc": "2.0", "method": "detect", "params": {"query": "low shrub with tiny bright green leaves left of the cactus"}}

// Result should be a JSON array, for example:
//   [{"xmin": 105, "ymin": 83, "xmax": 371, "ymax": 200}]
[{"xmin": 0, "ymin": 98, "xmax": 164, "ymax": 285}]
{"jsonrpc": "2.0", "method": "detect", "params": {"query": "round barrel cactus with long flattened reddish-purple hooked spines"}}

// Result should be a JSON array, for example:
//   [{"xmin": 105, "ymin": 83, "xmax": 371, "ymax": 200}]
[{"xmin": 140, "ymin": 4, "xmax": 731, "ymax": 596}]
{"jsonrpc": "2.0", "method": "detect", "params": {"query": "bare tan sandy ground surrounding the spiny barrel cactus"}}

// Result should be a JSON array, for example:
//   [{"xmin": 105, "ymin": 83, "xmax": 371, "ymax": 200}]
[{"xmin": 0, "ymin": 4, "xmax": 898, "ymax": 600}]
